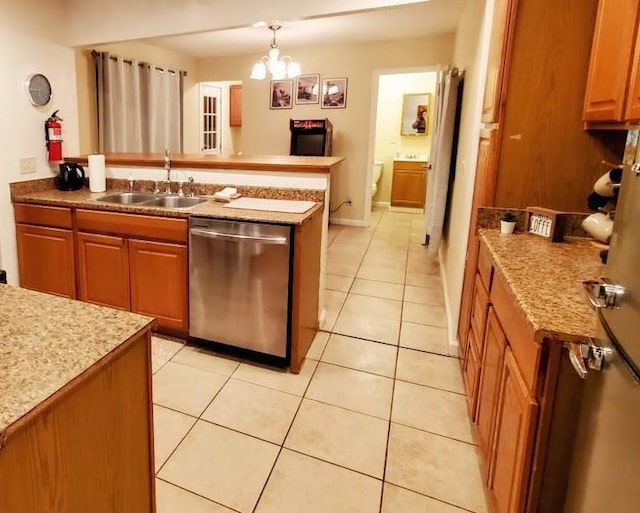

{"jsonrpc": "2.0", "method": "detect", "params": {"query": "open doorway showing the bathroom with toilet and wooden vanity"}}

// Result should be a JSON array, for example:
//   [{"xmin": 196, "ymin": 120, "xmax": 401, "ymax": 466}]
[{"xmin": 365, "ymin": 67, "xmax": 439, "ymax": 225}]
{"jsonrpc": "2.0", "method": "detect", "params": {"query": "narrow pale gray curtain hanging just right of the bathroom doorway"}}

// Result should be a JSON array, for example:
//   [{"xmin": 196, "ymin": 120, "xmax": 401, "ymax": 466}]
[{"xmin": 425, "ymin": 70, "xmax": 462, "ymax": 253}]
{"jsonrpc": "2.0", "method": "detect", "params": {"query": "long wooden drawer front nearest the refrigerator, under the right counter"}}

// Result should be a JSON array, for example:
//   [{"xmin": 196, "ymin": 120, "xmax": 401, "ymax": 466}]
[{"xmin": 490, "ymin": 274, "xmax": 541, "ymax": 393}]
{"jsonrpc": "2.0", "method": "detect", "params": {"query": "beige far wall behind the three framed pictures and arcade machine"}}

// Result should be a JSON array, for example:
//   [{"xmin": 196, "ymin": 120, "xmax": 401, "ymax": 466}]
[{"xmin": 197, "ymin": 34, "xmax": 454, "ymax": 223}]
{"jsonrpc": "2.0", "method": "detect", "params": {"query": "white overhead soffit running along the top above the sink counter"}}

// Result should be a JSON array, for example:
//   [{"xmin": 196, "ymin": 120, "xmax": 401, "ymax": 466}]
[{"xmin": 62, "ymin": 0, "xmax": 432, "ymax": 46}]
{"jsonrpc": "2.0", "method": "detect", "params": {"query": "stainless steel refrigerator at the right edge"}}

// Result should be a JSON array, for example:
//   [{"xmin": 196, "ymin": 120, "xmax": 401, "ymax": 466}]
[{"xmin": 564, "ymin": 130, "xmax": 640, "ymax": 513}]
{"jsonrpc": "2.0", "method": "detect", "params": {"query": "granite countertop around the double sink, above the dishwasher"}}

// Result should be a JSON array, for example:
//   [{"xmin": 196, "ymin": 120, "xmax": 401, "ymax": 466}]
[{"xmin": 13, "ymin": 188, "xmax": 322, "ymax": 225}]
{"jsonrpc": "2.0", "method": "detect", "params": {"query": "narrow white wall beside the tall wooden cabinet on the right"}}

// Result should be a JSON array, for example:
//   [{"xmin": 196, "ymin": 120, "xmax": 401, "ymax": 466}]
[{"xmin": 440, "ymin": 0, "xmax": 494, "ymax": 342}]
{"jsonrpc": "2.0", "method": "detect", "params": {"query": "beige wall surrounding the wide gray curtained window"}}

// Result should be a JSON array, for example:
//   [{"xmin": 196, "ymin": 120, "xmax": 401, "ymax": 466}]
[{"xmin": 75, "ymin": 41, "xmax": 199, "ymax": 154}]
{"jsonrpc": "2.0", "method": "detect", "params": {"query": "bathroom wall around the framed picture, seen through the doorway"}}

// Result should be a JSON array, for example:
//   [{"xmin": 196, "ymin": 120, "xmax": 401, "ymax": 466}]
[{"xmin": 373, "ymin": 72, "xmax": 438, "ymax": 204}]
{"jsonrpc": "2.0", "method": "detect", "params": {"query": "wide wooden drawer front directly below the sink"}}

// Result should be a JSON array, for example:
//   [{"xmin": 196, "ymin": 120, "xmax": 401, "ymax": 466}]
[{"xmin": 76, "ymin": 210, "xmax": 188, "ymax": 243}]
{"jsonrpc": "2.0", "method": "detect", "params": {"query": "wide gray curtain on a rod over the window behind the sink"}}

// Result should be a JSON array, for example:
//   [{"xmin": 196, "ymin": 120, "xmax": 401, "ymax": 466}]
[{"xmin": 93, "ymin": 52, "xmax": 183, "ymax": 153}]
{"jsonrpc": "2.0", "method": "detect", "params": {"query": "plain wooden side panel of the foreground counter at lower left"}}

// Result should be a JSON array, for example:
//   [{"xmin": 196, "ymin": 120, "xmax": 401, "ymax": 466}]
[{"xmin": 0, "ymin": 328, "xmax": 155, "ymax": 513}]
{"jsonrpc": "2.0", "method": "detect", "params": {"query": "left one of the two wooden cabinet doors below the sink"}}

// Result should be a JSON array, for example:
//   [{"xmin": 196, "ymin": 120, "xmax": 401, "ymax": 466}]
[{"xmin": 77, "ymin": 232, "xmax": 131, "ymax": 310}]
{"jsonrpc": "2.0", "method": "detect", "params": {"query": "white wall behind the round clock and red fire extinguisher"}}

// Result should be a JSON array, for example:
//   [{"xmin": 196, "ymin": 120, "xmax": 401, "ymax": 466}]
[{"xmin": 0, "ymin": 0, "xmax": 78, "ymax": 284}]
